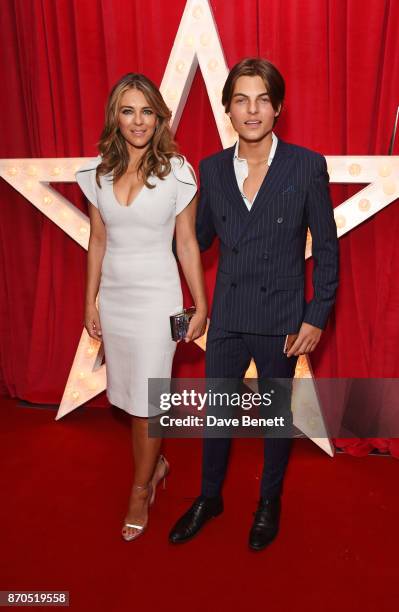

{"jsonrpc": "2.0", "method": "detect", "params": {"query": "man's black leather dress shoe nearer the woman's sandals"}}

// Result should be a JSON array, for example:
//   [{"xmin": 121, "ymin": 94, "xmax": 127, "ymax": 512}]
[{"xmin": 169, "ymin": 495, "xmax": 223, "ymax": 544}]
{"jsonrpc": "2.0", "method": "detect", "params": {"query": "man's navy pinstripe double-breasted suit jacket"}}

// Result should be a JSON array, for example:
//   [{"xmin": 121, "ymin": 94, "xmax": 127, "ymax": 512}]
[{"xmin": 197, "ymin": 139, "xmax": 338, "ymax": 334}]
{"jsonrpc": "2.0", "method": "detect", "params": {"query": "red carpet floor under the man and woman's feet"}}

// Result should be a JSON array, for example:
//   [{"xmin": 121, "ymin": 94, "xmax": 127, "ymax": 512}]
[{"xmin": 0, "ymin": 400, "xmax": 399, "ymax": 612}]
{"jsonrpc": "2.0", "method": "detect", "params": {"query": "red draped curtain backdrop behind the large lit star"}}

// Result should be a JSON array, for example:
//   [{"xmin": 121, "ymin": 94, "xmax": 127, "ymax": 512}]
[{"xmin": 0, "ymin": 0, "xmax": 399, "ymax": 456}]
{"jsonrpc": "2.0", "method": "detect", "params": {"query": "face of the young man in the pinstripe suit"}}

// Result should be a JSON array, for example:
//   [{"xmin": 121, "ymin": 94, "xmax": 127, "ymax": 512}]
[{"xmin": 227, "ymin": 76, "xmax": 281, "ymax": 142}]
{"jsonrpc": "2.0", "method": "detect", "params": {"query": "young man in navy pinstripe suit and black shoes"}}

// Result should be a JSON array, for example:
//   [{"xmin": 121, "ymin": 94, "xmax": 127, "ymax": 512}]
[{"xmin": 169, "ymin": 58, "xmax": 338, "ymax": 550}]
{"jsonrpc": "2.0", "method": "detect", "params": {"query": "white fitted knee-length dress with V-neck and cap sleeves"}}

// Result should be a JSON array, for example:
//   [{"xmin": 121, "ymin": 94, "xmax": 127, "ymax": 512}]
[{"xmin": 76, "ymin": 157, "xmax": 197, "ymax": 417}]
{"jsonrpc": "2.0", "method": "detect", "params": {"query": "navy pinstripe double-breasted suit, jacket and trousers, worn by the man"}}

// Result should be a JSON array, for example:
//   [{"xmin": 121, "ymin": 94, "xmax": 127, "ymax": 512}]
[{"xmin": 197, "ymin": 139, "xmax": 338, "ymax": 498}]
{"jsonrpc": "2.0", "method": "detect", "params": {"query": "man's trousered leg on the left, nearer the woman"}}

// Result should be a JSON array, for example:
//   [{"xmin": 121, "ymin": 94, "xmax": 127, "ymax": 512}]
[{"xmin": 201, "ymin": 325, "xmax": 251, "ymax": 497}]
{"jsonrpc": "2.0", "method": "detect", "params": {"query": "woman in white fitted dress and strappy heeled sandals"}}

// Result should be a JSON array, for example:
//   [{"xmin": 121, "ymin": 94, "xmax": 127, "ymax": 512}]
[{"xmin": 76, "ymin": 73, "xmax": 207, "ymax": 541}]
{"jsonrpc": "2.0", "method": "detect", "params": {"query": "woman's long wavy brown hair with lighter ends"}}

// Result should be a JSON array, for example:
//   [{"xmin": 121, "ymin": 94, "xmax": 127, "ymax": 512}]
[{"xmin": 96, "ymin": 72, "xmax": 183, "ymax": 189}]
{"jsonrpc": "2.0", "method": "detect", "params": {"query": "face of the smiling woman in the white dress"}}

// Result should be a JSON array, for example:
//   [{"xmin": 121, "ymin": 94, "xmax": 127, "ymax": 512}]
[{"xmin": 118, "ymin": 89, "xmax": 157, "ymax": 149}]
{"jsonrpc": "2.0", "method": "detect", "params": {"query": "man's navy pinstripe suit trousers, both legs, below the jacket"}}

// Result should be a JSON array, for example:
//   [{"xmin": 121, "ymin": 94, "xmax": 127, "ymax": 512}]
[{"xmin": 205, "ymin": 323, "xmax": 297, "ymax": 499}]
